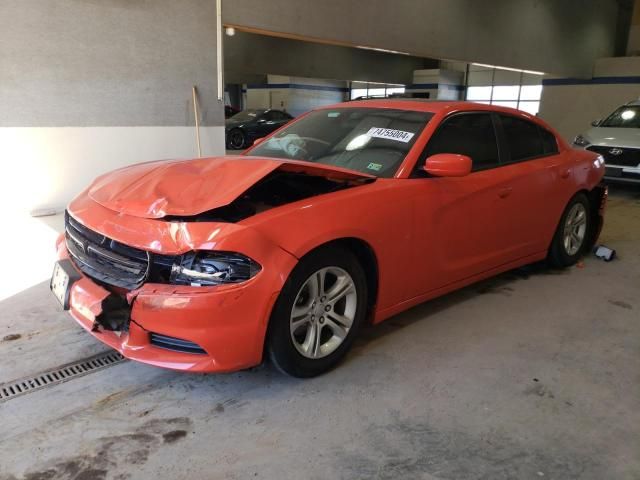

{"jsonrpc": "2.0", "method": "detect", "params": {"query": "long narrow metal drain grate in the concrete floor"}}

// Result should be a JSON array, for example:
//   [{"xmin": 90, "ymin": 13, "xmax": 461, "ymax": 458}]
[{"xmin": 0, "ymin": 352, "xmax": 126, "ymax": 402}]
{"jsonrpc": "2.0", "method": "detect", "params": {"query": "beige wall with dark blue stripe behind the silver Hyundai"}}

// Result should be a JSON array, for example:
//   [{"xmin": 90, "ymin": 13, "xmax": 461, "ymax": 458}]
[{"xmin": 539, "ymin": 57, "xmax": 640, "ymax": 140}]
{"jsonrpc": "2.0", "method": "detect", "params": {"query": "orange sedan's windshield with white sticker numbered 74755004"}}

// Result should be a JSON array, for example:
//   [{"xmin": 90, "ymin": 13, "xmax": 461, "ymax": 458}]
[{"xmin": 250, "ymin": 108, "xmax": 433, "ymax": 177}]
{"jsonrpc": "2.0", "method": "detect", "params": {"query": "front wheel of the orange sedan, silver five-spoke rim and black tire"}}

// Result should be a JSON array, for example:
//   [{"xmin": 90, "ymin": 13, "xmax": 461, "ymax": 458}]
[{"xmin": 266, "ymin": 246, "xmax": 368, "ymax": 378}]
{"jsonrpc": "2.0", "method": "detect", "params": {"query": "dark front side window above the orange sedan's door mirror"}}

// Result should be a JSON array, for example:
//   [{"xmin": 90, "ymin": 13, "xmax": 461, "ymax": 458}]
[{"xmin": 425, "ymin": 113, "xmax": 500, "ymax": 171}]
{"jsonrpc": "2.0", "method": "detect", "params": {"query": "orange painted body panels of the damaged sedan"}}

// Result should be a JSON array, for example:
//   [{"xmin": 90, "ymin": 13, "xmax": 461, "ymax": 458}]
[{"xmin": 58, "ymin": 100, "xmax": 604, "ymax": 372}]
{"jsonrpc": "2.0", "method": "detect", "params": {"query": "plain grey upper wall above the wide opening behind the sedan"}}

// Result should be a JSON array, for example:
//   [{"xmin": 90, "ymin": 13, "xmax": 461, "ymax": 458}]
[{"xmin": 223, "ymin": 0, "xmax": 618, "ymax": 76}]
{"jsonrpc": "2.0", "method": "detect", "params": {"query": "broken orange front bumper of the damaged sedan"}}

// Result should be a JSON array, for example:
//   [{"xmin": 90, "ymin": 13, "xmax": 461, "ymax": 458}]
[{"xmin": 57, "ymin": 237, "xmax": 295, "ymax": 372}]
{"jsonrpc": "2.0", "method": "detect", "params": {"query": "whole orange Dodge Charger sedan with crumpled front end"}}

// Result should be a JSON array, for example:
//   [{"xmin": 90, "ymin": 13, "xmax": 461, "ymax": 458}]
[{"xmin": 51, "ymin": 99, "xmax": 606, "ymax": 377}]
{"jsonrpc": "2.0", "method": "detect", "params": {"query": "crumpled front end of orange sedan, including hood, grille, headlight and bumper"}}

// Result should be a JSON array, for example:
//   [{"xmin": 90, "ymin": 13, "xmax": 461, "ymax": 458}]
[{"xmin": 57, "ymin": 159, "xmax": 375, "ymax": 372}]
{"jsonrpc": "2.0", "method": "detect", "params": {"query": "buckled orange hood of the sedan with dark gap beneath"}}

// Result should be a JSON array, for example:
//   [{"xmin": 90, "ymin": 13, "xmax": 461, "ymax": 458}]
[{"xmin": 86, "ymin": 157, "xmax": 376, "ymax": 221}]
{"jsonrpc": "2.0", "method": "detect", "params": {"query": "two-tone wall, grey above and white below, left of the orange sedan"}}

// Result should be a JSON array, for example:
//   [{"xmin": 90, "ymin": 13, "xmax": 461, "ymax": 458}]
[{"xmin": 0, "ymin": 0, "xmax": 224, "ymax": 214}]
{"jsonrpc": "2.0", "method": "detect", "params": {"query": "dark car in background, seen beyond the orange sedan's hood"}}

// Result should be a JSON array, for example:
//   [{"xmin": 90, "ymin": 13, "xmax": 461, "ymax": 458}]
[{"xmin": 225, "ymin": 109, "xmax": 293, "ymax": 150}]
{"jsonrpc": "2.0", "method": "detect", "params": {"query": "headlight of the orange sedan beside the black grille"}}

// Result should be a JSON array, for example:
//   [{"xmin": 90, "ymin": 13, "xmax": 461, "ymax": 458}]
[{"xmin": 171, "ymin": 252, "xmax": 261, "ymax": 287}]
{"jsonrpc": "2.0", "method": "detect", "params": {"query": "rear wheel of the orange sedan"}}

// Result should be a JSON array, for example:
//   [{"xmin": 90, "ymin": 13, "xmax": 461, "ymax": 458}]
[{"xmin": 547, "ymin": 193, "xmax": 592, "ymax": 268}]
